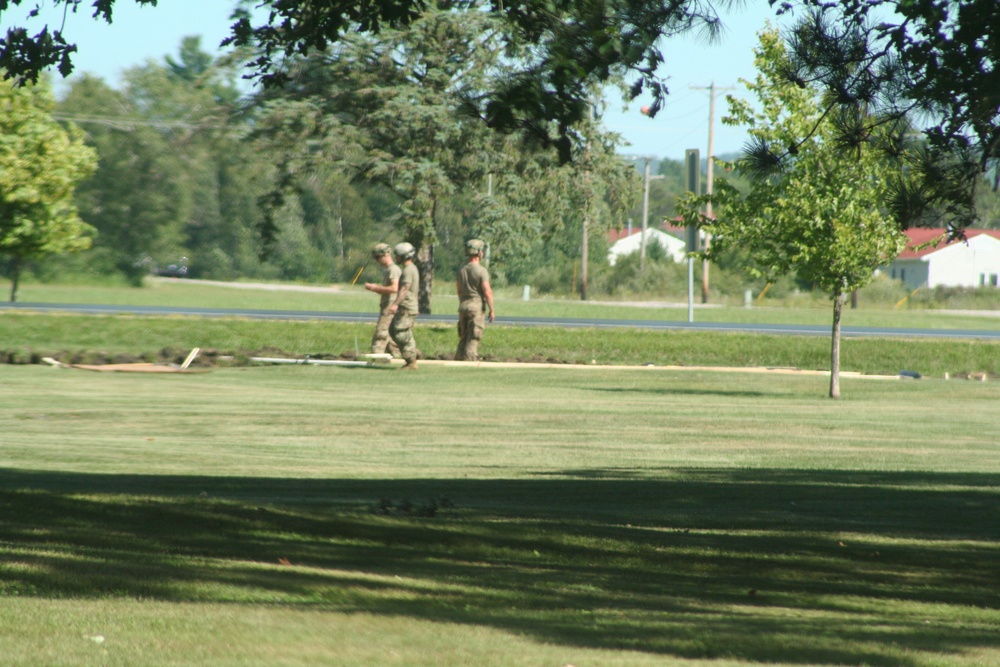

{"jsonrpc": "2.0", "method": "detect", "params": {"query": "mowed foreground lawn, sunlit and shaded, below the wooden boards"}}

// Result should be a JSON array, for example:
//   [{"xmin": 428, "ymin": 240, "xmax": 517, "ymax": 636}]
[{"xmin": 0, "ymin": 364, "xmax": 1000, "ymax": 667}]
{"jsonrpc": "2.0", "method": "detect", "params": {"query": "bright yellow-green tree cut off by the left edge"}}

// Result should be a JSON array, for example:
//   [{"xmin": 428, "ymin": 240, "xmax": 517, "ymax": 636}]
[{"xmin": 0, "ymin": 75, "xmax": 97, "ymax": 301}]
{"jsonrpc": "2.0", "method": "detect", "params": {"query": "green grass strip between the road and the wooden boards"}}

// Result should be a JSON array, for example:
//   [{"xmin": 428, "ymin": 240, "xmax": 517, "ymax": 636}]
[{"xmin": 0, "ymin": 312, "xmax": 1000, "ymax": 377}]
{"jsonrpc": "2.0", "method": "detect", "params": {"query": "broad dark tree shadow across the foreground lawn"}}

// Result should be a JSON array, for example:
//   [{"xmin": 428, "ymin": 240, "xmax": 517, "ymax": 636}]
[{"xmin": 0, "ymin": 469, "xmax": 1000, "ymax": 667}]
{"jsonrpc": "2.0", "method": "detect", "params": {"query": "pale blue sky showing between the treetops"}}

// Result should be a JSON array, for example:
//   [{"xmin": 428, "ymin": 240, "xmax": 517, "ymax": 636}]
[{"xmin": 0, "ymin": 0, "xmax": 788, "ymax": 160}]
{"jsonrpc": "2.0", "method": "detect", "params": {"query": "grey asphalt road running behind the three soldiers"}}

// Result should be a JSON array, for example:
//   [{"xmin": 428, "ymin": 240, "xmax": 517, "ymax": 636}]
[{"xmin": 7, "ymin": 302, "xmax": 1000, "ymax": 340}]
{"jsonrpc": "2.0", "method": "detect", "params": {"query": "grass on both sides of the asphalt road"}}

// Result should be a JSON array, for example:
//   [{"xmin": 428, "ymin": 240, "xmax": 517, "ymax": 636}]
[{"xmin": 0, "ymin": 280, "xmax": 1000, "ymax": 378}]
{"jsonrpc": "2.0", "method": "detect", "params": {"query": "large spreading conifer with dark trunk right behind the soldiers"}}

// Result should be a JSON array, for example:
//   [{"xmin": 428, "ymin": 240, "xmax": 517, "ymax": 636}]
[{"xmin": 249, "ymin": 7, "xmax": 502, "ymax": 313}]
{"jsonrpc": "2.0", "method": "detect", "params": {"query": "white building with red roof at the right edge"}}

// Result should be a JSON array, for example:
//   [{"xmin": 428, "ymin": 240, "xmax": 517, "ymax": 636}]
[{"xmin": 883, "ymin": 229, "xmax": 1000, "ymax": 289}]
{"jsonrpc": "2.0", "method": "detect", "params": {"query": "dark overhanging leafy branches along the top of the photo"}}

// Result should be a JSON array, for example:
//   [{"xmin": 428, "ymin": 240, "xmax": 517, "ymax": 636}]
[{"xmin": 0, "ymin": 0, "xmax": 1000, "ymax": 227}]
